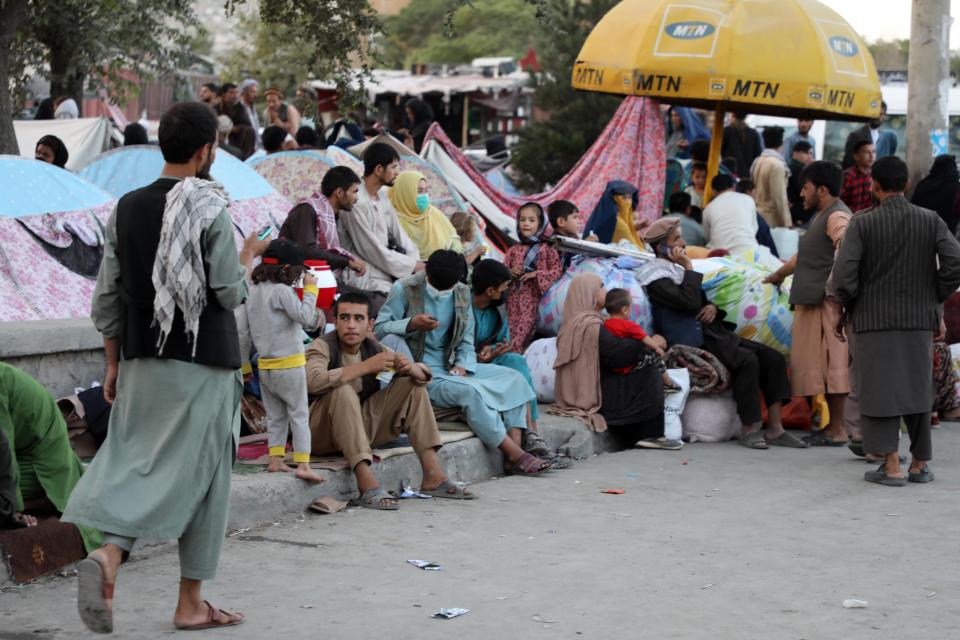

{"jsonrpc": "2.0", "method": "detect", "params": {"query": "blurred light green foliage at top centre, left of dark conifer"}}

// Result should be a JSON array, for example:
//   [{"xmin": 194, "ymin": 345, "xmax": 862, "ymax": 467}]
[{"xmin": 378, "ymin": 0, "xmax": 542, "ymax": 68}]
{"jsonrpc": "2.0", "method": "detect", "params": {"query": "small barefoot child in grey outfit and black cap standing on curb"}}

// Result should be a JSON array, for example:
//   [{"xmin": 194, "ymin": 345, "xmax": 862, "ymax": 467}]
[{"xmin": 238, "ymin": 240, "xmax": 324, "ymax": 483}]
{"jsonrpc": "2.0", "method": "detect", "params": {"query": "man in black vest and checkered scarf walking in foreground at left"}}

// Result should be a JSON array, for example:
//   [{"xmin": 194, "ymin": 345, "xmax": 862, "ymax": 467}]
[{"xmin": 63, "ymin": 102, "xmax": 266, "ymax": 633}]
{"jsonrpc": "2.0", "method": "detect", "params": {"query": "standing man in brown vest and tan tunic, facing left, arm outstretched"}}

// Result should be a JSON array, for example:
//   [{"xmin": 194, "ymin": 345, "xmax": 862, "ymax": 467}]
[{"xmin": 765, "ymin": 161, "xmax": 859, "ymax": 447}]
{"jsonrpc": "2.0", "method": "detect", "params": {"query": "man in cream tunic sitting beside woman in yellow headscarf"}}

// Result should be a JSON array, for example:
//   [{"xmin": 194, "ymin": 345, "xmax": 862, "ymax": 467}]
[{"xmin": 337, "ymin": 142, "xmax": 424, "ymax": 295}]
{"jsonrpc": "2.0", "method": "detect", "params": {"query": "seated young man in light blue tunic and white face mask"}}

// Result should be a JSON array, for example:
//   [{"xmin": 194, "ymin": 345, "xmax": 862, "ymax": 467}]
[{"xmin": 374, "ymin": 249, "xmax": 551, "ymax": 475}]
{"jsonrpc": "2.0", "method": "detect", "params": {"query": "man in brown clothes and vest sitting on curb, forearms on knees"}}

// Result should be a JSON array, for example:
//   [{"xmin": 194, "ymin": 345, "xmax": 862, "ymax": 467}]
[{"xmin": 307, "ymin": 292, "xmax": 476, "ymax": 511}]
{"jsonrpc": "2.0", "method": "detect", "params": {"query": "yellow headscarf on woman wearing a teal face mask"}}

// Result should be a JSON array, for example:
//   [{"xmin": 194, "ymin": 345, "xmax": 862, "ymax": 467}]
[{"xmin": 387, "ymin": 171, "xmax": 463, "ymax": 260}]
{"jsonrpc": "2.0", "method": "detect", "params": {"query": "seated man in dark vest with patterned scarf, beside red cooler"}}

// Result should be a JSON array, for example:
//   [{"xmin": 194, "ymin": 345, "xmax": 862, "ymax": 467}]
[{"xmin": 280, "ymin": 167, "xmax": 386, "ymax": 315}]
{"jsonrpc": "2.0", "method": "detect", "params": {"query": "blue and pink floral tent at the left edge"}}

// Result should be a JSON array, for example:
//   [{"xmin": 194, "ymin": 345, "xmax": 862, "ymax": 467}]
[{"xmin": 0, "ymin": 156, "xmax": 116, "ymax": 322}]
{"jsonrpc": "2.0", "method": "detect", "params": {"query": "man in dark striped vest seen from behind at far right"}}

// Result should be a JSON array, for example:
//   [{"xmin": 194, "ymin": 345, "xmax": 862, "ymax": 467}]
[{"xmin": 833, "ymin": 156, "xmax": 960, "ymax": 486}]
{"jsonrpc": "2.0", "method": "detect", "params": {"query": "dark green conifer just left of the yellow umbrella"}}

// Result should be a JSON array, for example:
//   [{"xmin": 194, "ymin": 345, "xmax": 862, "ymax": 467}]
[{"xmin": 512, "ymin": 0, "xmax": 623, "ymax": 191}]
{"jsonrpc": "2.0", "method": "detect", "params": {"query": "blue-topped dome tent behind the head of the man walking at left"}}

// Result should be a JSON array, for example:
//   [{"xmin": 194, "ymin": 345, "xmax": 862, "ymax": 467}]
[{"xmin": 79, "ymin": 145, "xmax": 292, "ymax": 241}]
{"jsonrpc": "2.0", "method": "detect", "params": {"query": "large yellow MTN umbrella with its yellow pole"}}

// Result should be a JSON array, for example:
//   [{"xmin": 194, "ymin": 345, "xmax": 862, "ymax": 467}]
[{"xmin": 573, "ymin": 0, "xmax": 881, "ymax": 200}]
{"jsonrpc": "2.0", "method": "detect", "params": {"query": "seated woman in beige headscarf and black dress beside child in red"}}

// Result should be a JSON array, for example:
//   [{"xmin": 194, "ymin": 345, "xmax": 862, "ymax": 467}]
[{"xmin": 552, "ymin": 273, "xmax": 682, "ymax": 449}]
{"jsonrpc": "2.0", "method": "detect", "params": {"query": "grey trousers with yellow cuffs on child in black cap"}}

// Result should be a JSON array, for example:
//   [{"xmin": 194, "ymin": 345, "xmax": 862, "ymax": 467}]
[{"xmin": 260, "ymin": 367, "xmax": 310, "ymax": 462}]
